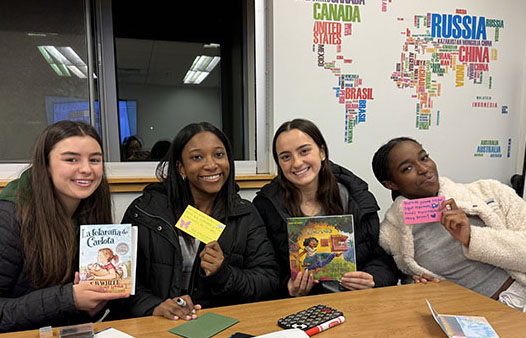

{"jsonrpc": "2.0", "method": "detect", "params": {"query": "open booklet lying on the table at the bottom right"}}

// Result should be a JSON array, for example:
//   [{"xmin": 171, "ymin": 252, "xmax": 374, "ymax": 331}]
[{"xmin": 426, "ymin": 299, "xmax": 499, "ymax": 338}]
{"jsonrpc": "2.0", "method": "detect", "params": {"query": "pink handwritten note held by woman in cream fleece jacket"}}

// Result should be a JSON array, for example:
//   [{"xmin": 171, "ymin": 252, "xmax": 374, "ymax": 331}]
[{"xmin": 402, "ymin": 196, "xmax": 445, "ymax": 224}]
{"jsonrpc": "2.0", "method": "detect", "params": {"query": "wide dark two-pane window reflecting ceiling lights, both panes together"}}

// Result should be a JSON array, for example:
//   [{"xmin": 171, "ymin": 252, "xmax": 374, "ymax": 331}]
[{"xmin": 0, "ymin": 0, "xmax": 268, "ymax": 177}]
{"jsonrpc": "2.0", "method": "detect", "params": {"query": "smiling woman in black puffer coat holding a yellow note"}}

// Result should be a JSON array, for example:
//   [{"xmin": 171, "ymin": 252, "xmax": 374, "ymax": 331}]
[{"xmin": 123, "ymin": 122, "xmax": 279, "ymax": 319}]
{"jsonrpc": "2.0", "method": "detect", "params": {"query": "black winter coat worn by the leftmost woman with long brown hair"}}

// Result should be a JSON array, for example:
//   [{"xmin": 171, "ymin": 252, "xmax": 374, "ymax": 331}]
[{"xmin": 0, "ymin": 201, "xmax": 91, "ymax": 332}]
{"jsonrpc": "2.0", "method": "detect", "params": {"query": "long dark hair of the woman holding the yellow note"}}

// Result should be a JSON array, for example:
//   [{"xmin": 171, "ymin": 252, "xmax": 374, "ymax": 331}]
[{"xmin": 156, "ymin": 122, "xmax": 236, "ymax": 219}]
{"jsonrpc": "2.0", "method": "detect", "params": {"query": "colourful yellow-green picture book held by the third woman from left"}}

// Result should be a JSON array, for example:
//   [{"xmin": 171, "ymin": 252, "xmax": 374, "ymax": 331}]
[{"xmin": 287, "ymin": 215, "xmax": 356, "ymax": 280}]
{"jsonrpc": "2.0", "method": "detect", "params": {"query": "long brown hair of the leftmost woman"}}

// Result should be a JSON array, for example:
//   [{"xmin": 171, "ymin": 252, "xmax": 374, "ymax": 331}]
[{"xmin": 17, "ymin": 121, "xmax": 112, "ymax": 289}]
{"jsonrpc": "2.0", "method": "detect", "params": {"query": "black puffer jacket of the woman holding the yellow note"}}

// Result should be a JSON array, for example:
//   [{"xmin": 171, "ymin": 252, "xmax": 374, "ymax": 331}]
[{"xmin": 122, "ymin": 183, "xmax": 279, "ymax": 316}]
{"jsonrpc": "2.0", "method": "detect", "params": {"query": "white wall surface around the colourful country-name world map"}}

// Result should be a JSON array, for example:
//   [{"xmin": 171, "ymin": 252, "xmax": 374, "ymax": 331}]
[{"xmin": 272, "ymin": 0, "xmax": 526, "ymax": 214}]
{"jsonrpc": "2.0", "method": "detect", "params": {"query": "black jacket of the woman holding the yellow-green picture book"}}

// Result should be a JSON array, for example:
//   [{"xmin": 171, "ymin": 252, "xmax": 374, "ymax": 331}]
[{"xmin": 253, "ymin": 163, "xmax": 399, "ymax": 297}]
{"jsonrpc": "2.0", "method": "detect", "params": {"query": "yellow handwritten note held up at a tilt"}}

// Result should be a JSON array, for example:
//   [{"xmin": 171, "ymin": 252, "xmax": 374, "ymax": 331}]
[{"xmin": 175, "ymin": 205, "xmax": 225, "ymax": 243}]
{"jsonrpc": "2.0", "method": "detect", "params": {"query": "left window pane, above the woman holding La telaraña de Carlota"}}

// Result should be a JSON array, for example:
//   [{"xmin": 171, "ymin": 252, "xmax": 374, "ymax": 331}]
[{"xmin": 0, "ymin": 0, "xmax": 91, "ymax": 162}]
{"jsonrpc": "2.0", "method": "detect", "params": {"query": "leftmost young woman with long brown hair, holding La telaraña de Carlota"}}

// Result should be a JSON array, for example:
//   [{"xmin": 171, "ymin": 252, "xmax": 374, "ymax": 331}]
[{"xmin": 0, "ymin": 121, "xmax": 126, "ymax": 332}]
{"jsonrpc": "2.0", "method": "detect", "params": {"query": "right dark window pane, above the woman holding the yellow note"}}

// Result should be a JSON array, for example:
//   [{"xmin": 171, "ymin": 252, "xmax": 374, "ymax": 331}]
[{"xmin": 112, "ymin": 0, "xmax": 255, "ymax": 160}]
